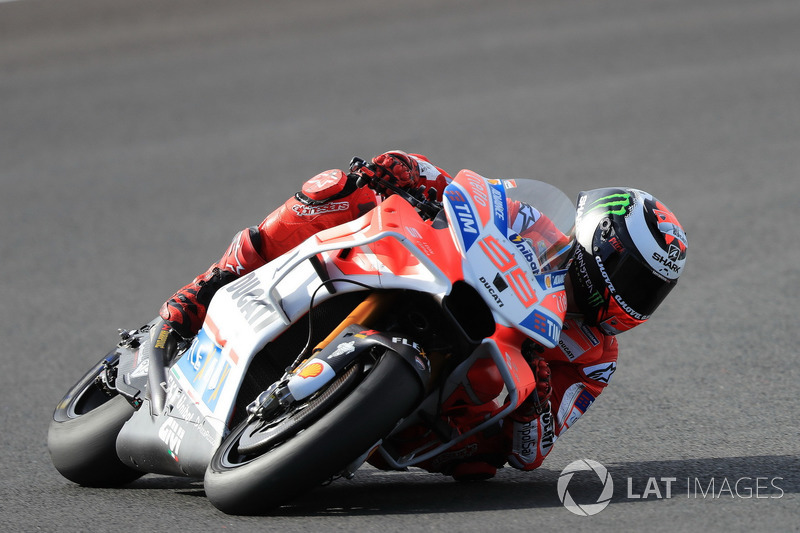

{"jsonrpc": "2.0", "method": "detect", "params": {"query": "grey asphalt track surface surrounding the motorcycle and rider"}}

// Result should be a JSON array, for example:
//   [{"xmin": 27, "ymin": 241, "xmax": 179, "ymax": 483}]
[{"xmin": 0, "ymin": 0, "xmax": 800, "ymax": 532}]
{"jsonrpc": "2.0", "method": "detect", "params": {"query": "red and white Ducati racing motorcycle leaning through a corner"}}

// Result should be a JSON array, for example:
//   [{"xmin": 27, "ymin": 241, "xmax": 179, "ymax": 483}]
[{"xmin": 48, "ymin": 170, "xmax": 575, "ymax": 514}]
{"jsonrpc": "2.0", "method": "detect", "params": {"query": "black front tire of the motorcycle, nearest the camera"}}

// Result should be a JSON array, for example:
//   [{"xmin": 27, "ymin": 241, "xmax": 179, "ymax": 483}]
[{"xmin": 205, "ymin": 352, "xmax": 423, "ymax": 515}]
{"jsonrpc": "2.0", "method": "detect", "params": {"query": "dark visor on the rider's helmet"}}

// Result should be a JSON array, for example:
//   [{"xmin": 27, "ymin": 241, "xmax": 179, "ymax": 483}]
[{"xmin": 598, "ymin": 242, "xmax": 675, "ymax": 316}]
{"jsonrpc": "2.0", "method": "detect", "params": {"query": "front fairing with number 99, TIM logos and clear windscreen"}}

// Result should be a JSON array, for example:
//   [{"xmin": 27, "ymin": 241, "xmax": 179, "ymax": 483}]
[{"xmin": 444, "ymin": 170, "xmax": 575, "ymax": 348}]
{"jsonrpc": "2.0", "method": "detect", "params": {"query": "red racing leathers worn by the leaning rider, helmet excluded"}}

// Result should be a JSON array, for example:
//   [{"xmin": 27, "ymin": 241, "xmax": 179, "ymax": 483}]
[{"xmin": 160, "ymin": 152, "xmax": 617, "ymax": 479}]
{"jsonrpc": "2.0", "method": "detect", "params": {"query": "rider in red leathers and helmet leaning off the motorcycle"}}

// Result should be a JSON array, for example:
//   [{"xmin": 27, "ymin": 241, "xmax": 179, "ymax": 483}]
[{"xmin": 160, "ymin": 150, "xmax": 687, "ymax": 479}]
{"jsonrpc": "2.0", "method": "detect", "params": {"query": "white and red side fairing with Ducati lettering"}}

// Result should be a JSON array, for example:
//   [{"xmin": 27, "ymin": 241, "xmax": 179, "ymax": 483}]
[{"xmin": 170, "ymin": 198, "xmax": 461, "ymax": 429}]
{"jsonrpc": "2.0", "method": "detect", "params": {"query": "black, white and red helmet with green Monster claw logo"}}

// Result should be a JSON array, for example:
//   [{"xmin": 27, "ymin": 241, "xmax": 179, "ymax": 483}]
[{"xmin": 570, "ymin": 187, "xmax": 688, "ymax": 335}]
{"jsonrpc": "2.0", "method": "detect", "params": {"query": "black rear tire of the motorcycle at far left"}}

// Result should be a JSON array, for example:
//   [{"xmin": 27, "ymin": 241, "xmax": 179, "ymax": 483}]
[{"xmin": 47, "ymin": 354, "xmax": 144, "ymax": 487}]
